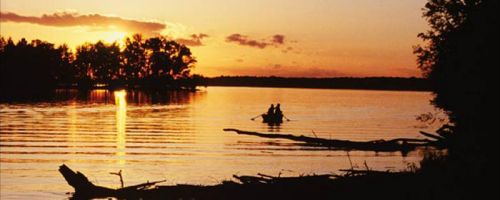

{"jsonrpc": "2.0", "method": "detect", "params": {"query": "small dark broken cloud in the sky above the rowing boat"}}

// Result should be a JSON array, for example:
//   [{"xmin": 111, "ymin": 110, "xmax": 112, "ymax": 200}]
[{"xmin": 226, "ymin": 33, "xmax": 285, "ymax": 49}]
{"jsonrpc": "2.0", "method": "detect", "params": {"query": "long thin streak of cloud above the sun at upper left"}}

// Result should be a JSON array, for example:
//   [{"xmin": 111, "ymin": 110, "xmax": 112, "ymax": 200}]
[{"xmin": 0, "ymin": 12, "xmax": 166, "ymax": 35}]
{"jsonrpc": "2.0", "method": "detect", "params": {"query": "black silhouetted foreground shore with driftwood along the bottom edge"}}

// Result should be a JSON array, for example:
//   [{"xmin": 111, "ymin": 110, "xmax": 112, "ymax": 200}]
[{"xmin": 59, "ymin": 152, "xmax": 494, "ymax": 199}]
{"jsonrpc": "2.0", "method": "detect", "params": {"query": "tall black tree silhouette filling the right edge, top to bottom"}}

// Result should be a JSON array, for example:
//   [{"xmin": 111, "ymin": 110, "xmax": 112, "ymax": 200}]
[{"xmin": 415, "ymin": 0, "xmax": 500, "ymax": 196}]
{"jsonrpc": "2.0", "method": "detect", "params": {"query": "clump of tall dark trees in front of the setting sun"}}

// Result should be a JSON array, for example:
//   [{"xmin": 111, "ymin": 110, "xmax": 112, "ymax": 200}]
[{"xmin": 0, "ymin": 34, "xmax": 196, "ymax": 97}]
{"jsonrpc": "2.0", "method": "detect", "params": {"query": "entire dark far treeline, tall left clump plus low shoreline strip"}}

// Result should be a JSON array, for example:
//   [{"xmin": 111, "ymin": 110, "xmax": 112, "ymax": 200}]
[{"xmin": 0, "ymin": 34, "xmax": 429, "ymax": 99}]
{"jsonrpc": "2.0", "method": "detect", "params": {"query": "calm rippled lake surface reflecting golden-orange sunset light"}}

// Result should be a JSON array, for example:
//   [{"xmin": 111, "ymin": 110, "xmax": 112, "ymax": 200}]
[{"xmin": 0, "ymin": 87, "xmax": 438, "ymax": 199}]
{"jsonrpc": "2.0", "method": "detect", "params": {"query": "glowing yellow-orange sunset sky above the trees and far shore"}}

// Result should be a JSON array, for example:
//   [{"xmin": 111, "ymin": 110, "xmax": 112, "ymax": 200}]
[{"xmin": 0, "ymin": 0, "xmax": 427, "ymax": 77}]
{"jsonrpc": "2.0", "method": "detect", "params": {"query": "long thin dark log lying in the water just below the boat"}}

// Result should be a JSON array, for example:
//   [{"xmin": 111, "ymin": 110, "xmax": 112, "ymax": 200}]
[{"xmin": 223, "ymin": 128, "xmax": 440, "ymax": 153}]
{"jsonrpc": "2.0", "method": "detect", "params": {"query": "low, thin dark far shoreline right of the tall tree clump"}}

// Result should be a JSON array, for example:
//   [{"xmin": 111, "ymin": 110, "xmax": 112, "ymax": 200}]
[{"xmin": 203, "ymin": 76, "xmax": 430, "ymax": 91}]
